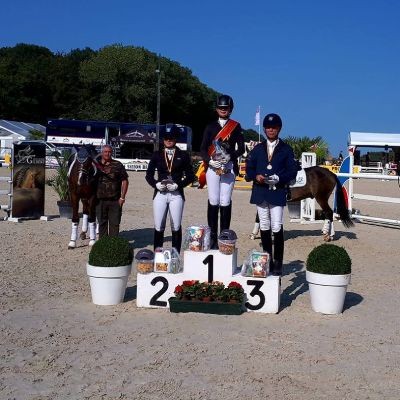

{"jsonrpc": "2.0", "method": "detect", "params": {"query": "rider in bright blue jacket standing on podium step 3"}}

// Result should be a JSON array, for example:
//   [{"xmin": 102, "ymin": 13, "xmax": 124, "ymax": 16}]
[{"xmin": 246, "ymin": 114, "xmax": 298, "ymax": 276}]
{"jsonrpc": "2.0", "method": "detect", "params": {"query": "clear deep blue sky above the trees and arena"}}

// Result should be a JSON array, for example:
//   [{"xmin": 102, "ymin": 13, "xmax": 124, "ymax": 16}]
[{"xmin": 0, "ymin": 0, "xmax": 400, "ymax": 156}]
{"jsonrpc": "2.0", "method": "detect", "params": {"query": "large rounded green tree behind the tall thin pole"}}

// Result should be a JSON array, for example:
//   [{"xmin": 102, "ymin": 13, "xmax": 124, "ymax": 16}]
[{"xmin": 79, "ymin": 45, "xmax": 217, "ymax": 150}]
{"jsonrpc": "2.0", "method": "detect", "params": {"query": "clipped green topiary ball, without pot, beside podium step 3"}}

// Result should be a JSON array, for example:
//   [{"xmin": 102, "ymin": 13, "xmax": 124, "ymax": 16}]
[{"xmin": 307, "ymin": 243, "xmax": 351, "ymax": 275}]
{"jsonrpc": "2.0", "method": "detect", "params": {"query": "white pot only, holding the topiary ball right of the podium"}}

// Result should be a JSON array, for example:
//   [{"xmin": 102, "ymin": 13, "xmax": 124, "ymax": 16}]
[{"xmin": 306, "ymin": 271, "xmax": 351, "ymax": 314}]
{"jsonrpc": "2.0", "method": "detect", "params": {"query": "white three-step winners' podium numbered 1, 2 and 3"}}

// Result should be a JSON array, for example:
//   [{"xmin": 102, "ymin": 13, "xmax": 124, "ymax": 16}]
[{"xmin": 136, "ymin": 250, "xmax": 281, "ymax": 313}]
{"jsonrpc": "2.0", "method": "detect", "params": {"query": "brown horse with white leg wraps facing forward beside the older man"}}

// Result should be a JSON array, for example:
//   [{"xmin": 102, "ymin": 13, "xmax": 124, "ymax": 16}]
[{"xmin": 68, "ymin": 144, "xmax": 98, "ymax": 249}]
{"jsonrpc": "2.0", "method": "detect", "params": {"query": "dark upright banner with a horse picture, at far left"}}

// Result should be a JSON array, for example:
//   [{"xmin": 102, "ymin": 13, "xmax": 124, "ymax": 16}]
[{"xmin": 11, "ymin": 142, "xmax": 46, "ymax": 218}]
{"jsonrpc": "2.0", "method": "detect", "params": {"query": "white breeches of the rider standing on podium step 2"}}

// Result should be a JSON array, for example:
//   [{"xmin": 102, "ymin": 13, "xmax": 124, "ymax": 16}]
[{"xmin": 153, "ymin": 190, "xmax": 185, "ymax": 232}]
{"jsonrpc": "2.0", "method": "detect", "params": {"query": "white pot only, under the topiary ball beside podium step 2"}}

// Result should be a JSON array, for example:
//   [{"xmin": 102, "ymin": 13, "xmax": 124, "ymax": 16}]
[{"xmin": 86, "ymin": 264, "xmax": 132, "ymax": 306}]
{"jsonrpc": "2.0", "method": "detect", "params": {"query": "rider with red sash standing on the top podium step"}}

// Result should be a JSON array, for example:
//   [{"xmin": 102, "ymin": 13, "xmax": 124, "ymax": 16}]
[{"xmin": 200, "ymin": 94, "xmax": 245, "ymax": 248}]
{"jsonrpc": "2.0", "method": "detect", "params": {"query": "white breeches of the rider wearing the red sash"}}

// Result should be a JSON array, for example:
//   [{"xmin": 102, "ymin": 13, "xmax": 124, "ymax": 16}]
[{"xmin": 206, "ymin": 161, "xmax": 236, "ymax": 207}]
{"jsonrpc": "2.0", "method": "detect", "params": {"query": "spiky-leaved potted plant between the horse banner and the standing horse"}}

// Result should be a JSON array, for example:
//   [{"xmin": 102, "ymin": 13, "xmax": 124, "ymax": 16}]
[{"xmin": 46, "ymin": 150, "xmax": 72, "ymax": 218}]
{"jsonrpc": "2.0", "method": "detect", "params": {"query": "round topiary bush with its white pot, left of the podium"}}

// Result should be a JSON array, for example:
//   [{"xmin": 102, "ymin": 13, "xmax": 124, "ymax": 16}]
[{"xmin": 86, "ymin": 236, "xmax": 133, "ymax": 305}]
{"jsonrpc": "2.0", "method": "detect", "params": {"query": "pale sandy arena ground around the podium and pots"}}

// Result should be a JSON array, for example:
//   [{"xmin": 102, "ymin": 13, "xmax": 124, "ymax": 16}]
[{"xmin": 0, "ymin": 168, "xmax": 400, "ymax": 400}]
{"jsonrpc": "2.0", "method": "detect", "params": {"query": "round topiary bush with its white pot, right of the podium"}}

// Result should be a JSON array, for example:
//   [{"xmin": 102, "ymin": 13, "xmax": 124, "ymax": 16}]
[{"xmin": 306, "ymin": 243, "xmax": 351, "ymax": 314}]
